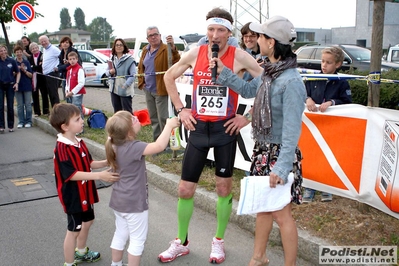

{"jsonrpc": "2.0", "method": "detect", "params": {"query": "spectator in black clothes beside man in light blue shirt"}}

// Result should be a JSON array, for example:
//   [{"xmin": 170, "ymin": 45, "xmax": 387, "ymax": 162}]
[{"xmin": 29, "ymin": 42, "xmax": 50, "ymax": 116}]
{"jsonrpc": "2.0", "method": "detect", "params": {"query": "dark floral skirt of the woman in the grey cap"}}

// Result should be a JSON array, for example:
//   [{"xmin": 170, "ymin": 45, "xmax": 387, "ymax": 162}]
[{"xmin": 250, "ymin": 143, "xmax": 302, "ymax": 204}]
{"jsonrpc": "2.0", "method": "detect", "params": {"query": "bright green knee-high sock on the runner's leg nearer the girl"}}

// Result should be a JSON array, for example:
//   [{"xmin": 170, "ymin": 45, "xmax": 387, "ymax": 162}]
[{"xmin": 177, "ymin": 198, "xmax": 194, "ymax": 244}]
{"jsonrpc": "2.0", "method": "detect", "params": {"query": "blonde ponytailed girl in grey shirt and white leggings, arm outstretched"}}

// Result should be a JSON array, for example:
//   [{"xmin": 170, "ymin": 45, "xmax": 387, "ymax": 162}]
[{"xmin": 105, "ymin": 111, "xmax": 180, "ymax": 266}]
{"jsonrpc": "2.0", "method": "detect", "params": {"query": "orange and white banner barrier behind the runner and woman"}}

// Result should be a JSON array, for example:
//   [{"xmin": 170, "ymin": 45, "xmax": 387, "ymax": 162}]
[{"xmin": 176, "ymin": 83, "xmax": 399, "ymax": 219}]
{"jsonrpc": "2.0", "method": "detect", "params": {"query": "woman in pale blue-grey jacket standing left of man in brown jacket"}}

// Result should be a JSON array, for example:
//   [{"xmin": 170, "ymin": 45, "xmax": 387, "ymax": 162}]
[{"xmin": 107, "ymin": 38, "xmax": 136, "ymax": 113}]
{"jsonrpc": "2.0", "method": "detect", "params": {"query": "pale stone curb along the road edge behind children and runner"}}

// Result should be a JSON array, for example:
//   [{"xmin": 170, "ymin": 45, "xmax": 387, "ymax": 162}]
[{"xmin": 33, "ymin": 117, "xmax": 333, "ymax": 265}]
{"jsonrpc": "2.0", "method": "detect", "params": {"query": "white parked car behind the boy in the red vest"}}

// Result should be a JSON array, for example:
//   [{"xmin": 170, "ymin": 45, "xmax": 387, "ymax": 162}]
[{"xmin": 78, "ymin": 50, "xmax": 109, "ymax": 87}]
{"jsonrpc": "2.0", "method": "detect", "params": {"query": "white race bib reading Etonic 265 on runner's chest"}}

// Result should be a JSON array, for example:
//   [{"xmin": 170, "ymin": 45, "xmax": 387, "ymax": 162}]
[{"xmin": 197, "ymin": 85, "xmax": 229, "ymax": 116}]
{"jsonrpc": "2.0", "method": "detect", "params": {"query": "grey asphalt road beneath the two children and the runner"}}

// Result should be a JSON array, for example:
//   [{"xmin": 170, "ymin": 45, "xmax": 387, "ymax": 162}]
[{"xmin": 0, "ymin": 88, "xmax": 312, "ymax": 266}]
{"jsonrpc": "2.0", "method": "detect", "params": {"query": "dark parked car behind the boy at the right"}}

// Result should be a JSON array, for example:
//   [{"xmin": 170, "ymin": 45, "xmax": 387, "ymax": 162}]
[{"xmin": 295, "ymin": 44, "xmax": 399, "ymax": 71}]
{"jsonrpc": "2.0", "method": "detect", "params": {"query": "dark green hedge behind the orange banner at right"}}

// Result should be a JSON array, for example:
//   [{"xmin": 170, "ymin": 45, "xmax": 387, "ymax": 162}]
[{"xmin": 346, "ymin": 70, "xmax": 399, "ymax": 110}]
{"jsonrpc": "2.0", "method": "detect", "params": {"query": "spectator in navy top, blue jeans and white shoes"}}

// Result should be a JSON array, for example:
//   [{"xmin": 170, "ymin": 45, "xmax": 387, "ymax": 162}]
[{"xmin": 14, "ymin": 46, "xmax": 33, "ymax": 128}]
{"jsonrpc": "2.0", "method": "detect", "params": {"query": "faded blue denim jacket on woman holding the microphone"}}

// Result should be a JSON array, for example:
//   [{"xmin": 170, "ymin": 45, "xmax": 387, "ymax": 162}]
[{"xmin": 216, "ymin": 67, "xmax": 306, "ymax": 182}]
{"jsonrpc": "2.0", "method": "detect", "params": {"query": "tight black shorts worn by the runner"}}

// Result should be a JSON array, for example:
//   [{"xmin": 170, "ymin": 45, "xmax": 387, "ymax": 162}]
[{"xmin": 181, "ymin": 120, "xmax": 237, "ymax": 183}]
